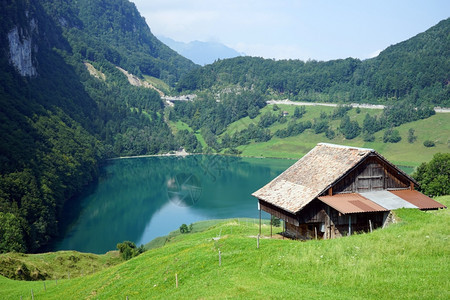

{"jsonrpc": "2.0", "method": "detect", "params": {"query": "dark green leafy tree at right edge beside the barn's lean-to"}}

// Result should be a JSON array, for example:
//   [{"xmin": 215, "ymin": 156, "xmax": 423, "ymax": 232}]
[{"xmin": 412, "ymin": 153, "xmax": 450, "ymax": 196}]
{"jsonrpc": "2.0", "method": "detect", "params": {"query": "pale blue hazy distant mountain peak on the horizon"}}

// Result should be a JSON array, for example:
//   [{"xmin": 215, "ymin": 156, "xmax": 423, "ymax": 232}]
[{"xmin": 158, "ymin": 36, "xmax": 245, "ymax": 66}]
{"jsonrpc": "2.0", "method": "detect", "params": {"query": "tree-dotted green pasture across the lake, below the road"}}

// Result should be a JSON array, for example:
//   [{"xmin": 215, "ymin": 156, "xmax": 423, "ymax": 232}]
[{"xmin": 237, "ymin": 105, "xmax": 450, "ymax": 167}]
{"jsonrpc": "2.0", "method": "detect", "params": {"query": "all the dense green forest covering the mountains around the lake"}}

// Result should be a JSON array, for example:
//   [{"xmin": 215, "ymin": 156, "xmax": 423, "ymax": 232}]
[{"xmin": 0, "ymin": 0, "xmax": 450, "ymax": 252}]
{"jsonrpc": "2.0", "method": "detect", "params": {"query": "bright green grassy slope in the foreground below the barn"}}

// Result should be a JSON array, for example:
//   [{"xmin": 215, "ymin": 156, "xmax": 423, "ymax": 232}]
[{"xmin": 0, "ymin": 196, "xmax": 450, "ymax": 299}]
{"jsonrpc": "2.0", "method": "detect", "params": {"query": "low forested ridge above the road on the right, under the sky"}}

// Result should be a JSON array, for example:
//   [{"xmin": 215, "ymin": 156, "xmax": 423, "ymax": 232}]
[{"xmin": 178, "ymin": 19, "xmax": 450, "ymax": 107}]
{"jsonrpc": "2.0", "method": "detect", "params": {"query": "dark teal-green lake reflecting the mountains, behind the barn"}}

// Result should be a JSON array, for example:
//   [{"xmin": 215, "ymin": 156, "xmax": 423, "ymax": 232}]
[{"xmin": 51, "ymin": 155, "xmax": 295, "ymax": 253}]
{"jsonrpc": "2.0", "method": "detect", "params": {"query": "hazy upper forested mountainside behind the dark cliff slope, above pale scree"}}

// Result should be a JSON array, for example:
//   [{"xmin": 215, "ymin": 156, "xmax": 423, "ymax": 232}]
[{"xmin": 44, "ymin": 0, "xmax": 196, "ymax": 84}]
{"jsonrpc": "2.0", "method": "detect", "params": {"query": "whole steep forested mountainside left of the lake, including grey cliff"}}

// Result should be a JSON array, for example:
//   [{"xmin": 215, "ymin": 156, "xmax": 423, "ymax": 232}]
[{"xmin": 0, "ymin": 0, "xmax": 196, "ymax": 252}]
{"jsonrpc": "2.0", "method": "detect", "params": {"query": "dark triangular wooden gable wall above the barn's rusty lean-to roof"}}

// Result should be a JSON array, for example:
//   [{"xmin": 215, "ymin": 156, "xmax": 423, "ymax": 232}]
[{"xmin": 333, "ymin": 156, "xmax": 409, "ymax": 194}]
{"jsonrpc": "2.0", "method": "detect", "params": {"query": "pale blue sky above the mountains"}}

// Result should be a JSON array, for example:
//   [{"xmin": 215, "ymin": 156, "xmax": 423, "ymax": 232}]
[{"xmin": 131, "ymin": 0, "xmax": 450, "ymax": 60}]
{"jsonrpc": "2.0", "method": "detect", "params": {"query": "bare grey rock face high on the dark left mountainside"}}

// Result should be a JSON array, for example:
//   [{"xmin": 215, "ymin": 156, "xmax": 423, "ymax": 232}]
[{"xmin": 8, "ymin": 19, "xmax": 38, "ymax": 77}]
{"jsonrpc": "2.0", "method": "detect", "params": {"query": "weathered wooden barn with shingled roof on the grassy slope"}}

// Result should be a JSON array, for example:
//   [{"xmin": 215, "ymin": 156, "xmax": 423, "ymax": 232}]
[{"xmin": 252, "ymin": 143, "xmax": 445, "ymax": 239}]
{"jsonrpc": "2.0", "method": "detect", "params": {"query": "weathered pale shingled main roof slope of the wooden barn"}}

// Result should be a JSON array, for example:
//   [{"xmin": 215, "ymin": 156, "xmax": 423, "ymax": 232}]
[{"xmin": 252, "ymin": 143, "xmax": 382, "ymax": 213}]
